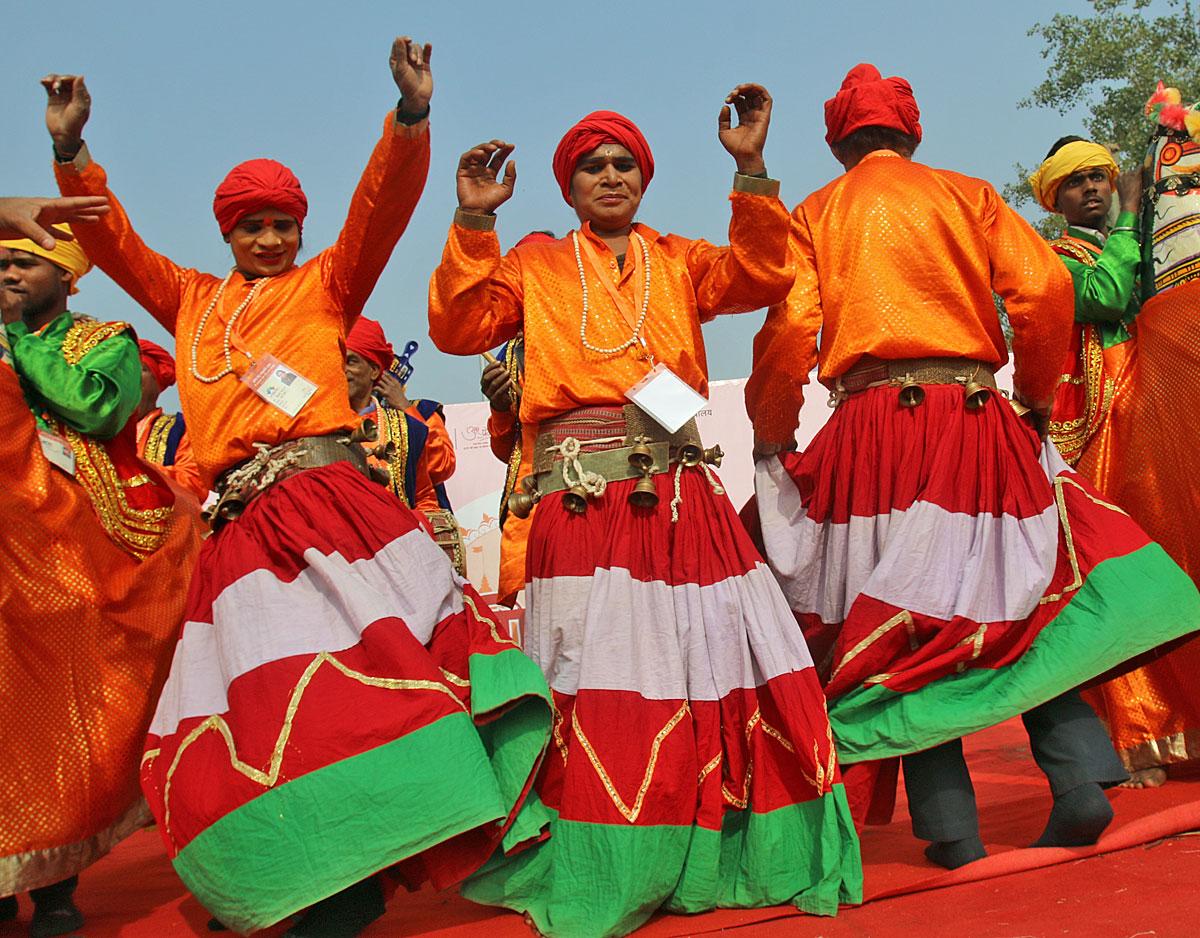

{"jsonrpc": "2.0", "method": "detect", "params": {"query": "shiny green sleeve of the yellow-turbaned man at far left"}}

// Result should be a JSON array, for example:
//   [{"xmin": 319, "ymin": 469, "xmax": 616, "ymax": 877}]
[{"xmin": 7, "ymin": 323, "xmax": 142, "ymax": 440}]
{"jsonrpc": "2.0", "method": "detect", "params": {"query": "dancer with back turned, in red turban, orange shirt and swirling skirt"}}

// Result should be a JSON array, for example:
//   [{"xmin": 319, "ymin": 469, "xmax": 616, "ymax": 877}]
[{"xmin": 746, "ymin": 65, "xmax": 1200, "ymax": 867}]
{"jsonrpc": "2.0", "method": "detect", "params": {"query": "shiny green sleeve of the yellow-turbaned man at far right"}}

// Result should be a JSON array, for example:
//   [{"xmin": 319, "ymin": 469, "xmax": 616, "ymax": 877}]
[{"xmin": 1062, "ymin": 212, "xmax": 1141, "ymax": 348}]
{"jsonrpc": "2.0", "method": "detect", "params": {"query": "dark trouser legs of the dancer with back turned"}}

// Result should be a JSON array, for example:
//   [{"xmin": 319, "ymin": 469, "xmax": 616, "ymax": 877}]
[{"xmin": 901, "ymin": 691, "xmax": 1129, "ymax": 841}]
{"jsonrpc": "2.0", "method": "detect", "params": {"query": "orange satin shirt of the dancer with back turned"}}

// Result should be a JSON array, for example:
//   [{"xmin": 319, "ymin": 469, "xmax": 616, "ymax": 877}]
[{"xmin": 746, "ymin": 150, "xmax": 1074, "ymax": 444}]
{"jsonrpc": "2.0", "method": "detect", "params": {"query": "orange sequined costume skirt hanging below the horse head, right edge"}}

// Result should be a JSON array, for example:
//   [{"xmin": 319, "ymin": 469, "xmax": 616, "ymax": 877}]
[{"xmin": 1078, "ymin": 282, "xmax": 1200, "ymax": 769}]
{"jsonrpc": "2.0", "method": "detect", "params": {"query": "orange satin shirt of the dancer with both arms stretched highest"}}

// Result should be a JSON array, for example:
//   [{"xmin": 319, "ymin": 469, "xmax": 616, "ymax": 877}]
[{"xmin": 55, "ymin": 115, "xmax": 430, "ymax": 487}]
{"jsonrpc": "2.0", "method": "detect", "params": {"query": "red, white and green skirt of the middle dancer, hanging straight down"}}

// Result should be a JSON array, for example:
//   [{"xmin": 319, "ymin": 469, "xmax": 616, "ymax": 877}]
[{"xmin": 463, "ymin": 469, "xmax": 862, "ymax": 938}]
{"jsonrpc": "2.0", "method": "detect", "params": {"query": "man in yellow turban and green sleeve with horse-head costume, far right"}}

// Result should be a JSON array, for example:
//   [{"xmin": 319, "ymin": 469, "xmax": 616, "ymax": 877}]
[{"xmin": 1030, "ymin": 113, "xmax": 1200, "ymax": 787}]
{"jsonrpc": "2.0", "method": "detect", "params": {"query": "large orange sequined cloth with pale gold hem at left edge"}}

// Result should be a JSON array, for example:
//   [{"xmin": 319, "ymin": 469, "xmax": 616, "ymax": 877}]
[{"xmin": 0, "ymin": 365, "xmax": 200, "ymax": 896}]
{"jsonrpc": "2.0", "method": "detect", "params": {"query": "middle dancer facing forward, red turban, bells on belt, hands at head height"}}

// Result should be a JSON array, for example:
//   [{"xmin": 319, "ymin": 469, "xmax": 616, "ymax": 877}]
[{"xmin": 430, "ymin": 85, "xmax": 860, "ymax": 937}]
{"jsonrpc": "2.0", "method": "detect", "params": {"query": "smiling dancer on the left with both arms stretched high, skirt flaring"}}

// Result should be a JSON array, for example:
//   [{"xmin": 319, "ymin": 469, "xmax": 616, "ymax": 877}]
[{"xmin": 44, "ymin": 38, "xmax": 550, "ymax": 936}]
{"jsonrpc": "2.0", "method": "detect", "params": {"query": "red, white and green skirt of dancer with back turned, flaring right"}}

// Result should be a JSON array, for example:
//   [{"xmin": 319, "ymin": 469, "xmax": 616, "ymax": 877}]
[{"xmin": 756, "ymin": 385, "xmax": 1200, "ymax": 777}]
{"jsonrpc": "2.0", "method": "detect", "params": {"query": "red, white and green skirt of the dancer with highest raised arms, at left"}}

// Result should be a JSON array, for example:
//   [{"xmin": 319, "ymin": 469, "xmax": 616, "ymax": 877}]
[{"xmin": 142, "ymin": 463, "xmax": 551, "ymax": 932}]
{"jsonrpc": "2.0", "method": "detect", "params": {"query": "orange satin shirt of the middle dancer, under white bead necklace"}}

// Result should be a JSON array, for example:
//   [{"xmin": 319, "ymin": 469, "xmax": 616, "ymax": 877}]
[{"xmin": 430, "ymin": 183, "xmax": 792, "ymax": 427}]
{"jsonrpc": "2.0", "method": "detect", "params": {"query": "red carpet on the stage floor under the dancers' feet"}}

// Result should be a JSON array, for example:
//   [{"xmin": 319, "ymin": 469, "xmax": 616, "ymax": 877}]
[{"xmin": 7, "ymin": 721, "xmax": 1200, "ymax": 938}]
